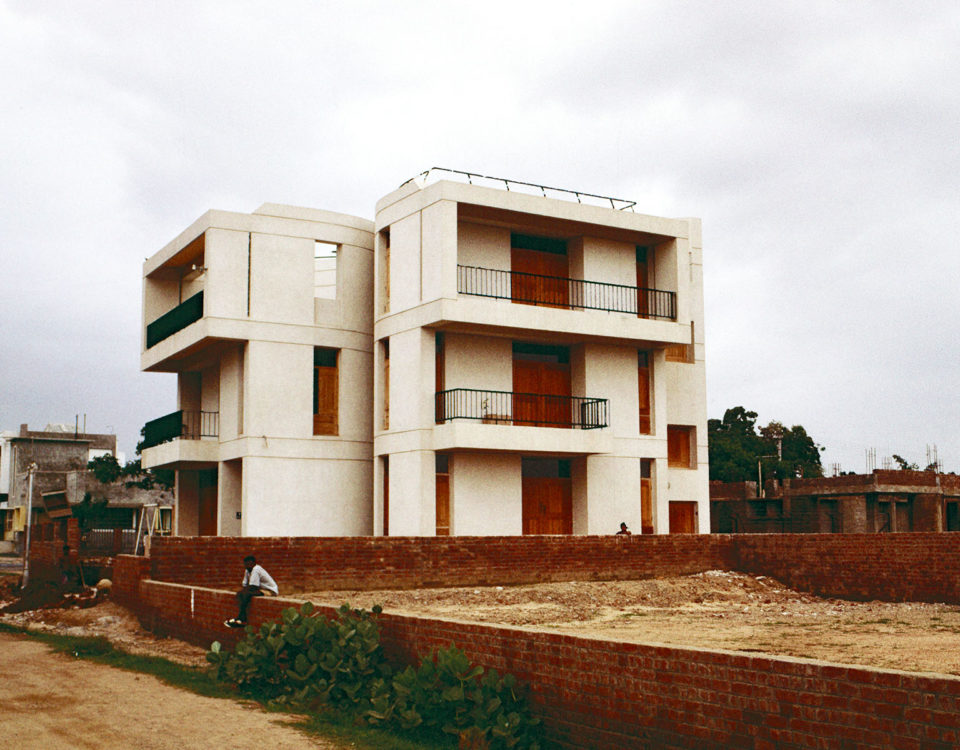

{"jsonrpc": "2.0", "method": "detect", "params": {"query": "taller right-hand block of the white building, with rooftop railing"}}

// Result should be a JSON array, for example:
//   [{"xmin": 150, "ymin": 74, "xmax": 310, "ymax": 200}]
[{"xmin": 374, "ymin": 171, "xmax": 710, "ymax": 535}]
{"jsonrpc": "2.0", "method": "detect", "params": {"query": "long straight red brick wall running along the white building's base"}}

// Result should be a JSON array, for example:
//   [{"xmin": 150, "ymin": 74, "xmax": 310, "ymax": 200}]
[{"xmin": 150, "ymin": 534, "xmax": 732, "ymax": 594}]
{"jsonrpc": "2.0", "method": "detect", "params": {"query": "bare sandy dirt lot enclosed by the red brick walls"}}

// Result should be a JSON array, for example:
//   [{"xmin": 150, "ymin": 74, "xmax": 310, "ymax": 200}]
[{"xmin": 306, "ymin": 570, "xmax": 960, "ymax": 675}]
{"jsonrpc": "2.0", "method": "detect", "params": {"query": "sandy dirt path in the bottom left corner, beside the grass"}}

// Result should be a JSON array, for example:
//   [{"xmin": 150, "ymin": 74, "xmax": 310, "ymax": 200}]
[{"xmin": 0, "ymin": 634, "xmax": 345, "ymax": 750}]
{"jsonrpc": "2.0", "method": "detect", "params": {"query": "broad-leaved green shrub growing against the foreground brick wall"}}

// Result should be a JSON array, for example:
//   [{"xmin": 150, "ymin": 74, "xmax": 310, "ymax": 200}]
[{"xmin": 207, "ymin": 602, "xmax": 540, "ymax": 750}]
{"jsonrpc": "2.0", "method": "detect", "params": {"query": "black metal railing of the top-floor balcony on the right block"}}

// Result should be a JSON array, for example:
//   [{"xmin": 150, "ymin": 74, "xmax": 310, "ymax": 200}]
[{"xmin": 457, "ymin": 265, "xmax": 677, "ymax": 320}]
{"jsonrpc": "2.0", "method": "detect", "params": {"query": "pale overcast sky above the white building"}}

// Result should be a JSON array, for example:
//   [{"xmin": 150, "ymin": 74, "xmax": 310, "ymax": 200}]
[{"xmin": 0, "ymin": 0, "xmax": 960, "ymax": 472}]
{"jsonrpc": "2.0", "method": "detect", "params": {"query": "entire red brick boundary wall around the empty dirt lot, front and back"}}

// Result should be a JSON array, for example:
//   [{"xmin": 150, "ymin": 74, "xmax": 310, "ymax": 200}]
[{"xmin": 115, "ymin": 533, "xmax": 960, "ymax": 748}]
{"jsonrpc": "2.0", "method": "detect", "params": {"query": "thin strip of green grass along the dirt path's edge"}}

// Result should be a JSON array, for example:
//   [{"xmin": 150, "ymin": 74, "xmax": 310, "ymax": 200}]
[{"xmin": 0, "ymin": 623, "xmax": 442, "ymax": 750}]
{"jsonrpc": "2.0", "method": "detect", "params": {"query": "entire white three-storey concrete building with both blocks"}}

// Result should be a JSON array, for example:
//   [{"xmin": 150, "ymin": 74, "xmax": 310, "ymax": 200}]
[{"xmin": 141, "ymin": 173, "xmax": 710, "ymax": 535}]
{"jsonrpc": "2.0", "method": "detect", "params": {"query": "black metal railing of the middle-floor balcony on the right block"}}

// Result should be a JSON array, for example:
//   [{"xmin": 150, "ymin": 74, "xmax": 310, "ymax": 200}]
[{"xmin": 435, "ymin": 388, "xmax": 610, "ymax": 430}]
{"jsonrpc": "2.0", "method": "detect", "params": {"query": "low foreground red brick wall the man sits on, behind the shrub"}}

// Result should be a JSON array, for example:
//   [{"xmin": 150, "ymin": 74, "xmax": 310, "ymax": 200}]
[{"xmin": 131, "ymin": 581, "xmax": 960, "ymax": 749}]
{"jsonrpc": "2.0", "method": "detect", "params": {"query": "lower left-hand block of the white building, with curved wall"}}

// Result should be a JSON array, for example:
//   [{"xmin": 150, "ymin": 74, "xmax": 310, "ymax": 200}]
[{"xmin": 140, "ymin": 204, "xmax": 373, "ymax": 536}]
